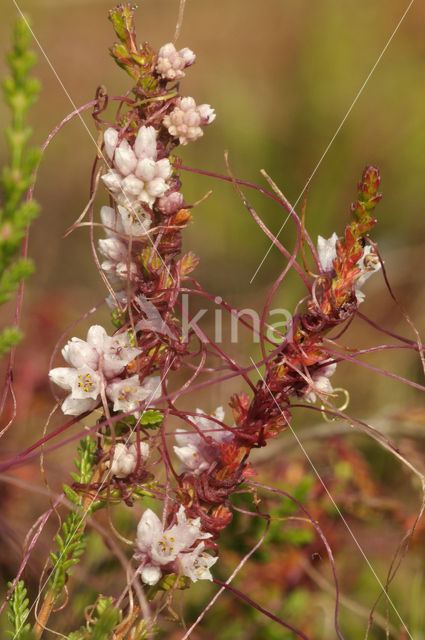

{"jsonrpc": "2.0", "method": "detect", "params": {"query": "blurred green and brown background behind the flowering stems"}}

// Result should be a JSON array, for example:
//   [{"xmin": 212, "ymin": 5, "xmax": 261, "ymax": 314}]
[{"xmin": 0, "ymin": 0, "xmax": 425, "ymax": 640}]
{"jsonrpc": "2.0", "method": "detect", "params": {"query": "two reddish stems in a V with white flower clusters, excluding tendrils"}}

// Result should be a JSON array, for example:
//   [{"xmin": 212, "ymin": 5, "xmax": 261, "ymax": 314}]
[{"xmin": 50, "ymin": 5, "xmax": 380, "ymax": 604}]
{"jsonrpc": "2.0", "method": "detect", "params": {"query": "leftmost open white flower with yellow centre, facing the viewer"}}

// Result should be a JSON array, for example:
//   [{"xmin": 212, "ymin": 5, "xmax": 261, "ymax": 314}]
[{"xmin": 49, "ymin": 365, "xmax": 101, "ymax": 416}]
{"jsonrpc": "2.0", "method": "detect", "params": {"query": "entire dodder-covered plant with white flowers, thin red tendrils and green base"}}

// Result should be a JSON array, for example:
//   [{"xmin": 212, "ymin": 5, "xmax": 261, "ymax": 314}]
[{"xmin": 2, "ymin": 4, "xmax": 417, "ymax": 640}]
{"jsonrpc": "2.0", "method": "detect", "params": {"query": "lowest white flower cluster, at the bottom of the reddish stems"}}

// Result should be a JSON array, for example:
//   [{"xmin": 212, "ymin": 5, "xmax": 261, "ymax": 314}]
[{"xmin": 135, "ymin": 506, "xmax": 215, "ymax": 585}]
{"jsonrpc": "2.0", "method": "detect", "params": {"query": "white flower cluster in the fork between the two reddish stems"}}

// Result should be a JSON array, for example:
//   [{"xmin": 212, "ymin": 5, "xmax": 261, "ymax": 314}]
[{"xmin": 173, "ymin": 407, "xmax": 233, "ymax": 475}]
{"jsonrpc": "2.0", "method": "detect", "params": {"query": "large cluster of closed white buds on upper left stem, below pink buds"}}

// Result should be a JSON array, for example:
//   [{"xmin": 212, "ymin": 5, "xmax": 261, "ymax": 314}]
[{"xmin": 102, "ymin": 126, "xmax": 172, "ymax": 209}]
